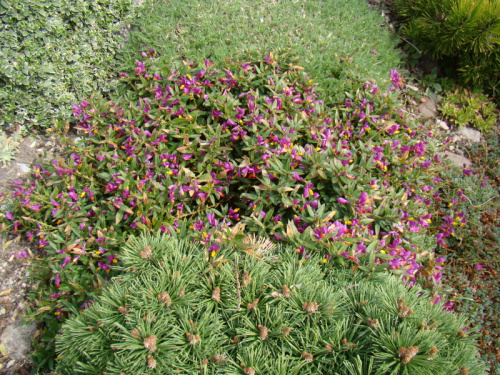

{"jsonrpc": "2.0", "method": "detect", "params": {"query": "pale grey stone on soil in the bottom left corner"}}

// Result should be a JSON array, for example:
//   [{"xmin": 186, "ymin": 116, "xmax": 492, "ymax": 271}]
[{"xmin": 0, "ymin": 321, "xmax": 36, "ymax": 360}]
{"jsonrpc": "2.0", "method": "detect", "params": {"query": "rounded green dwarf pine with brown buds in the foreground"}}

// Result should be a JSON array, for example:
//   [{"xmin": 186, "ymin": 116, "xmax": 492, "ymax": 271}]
[{"xmin": 57, "ymin": 233, "xmax": 486, "ymax": 375}]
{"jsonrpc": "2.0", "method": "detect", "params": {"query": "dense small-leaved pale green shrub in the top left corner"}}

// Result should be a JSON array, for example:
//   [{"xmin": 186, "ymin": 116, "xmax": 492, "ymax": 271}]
[{"xmin": 0, "ymin": 0, "xmax": 139, "ymax": 128}]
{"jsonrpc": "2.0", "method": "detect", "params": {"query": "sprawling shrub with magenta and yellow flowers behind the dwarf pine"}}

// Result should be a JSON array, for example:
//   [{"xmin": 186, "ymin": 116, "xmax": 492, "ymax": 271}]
[{"xmin": 0, "ymin": 50, "xmax": 465, "ymax": 368}]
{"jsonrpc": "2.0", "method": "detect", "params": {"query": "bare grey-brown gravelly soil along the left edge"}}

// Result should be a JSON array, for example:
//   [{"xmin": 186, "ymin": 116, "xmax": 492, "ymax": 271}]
[{"xmin": 0, "ymin": 136, "xmax": 66, "ymax": 375}]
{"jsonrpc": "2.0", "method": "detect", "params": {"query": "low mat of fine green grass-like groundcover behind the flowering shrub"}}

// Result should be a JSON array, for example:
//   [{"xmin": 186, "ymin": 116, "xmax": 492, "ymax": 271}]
[{"xmin": 121, "ymin": 0, "xmax": 400, "ymax": 100}]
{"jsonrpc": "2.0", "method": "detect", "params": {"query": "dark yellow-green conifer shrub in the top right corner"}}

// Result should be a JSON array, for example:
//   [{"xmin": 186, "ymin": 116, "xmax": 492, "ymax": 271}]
[{"xmin": 393, "ymin": 0, "xmax": 500, "ymax": 89}]
